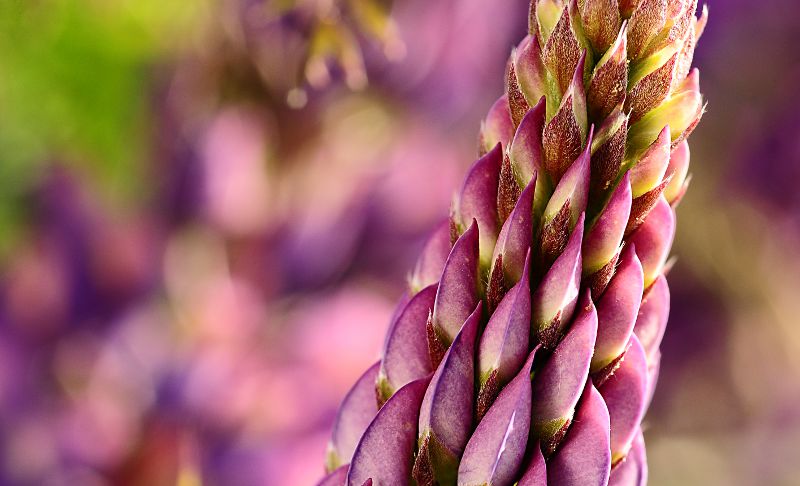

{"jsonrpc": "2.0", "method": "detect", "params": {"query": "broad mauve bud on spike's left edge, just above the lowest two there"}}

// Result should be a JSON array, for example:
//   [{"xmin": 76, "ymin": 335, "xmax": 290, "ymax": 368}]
[{"xmin": 378, "ymin": 284, "xmax": 437, "ymax": 401}]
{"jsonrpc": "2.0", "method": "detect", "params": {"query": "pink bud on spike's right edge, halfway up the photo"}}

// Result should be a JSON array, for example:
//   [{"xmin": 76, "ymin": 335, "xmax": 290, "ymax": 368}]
[{"xmin": 630, "ymin": 197, "xmax": 675, "ymax": 288}]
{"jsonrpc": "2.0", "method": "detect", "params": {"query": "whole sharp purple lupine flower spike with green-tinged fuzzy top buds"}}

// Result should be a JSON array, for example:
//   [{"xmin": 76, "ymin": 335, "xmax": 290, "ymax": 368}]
[{"xmin": 320, "ymin": 0, "xmax": 708, "ymax": 486}]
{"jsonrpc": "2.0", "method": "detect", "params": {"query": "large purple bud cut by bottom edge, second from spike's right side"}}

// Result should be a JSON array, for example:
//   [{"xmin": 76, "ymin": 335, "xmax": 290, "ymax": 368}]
[{"xmin": 547, "ymin": 381, "xmax": 611, "ymax": 486}]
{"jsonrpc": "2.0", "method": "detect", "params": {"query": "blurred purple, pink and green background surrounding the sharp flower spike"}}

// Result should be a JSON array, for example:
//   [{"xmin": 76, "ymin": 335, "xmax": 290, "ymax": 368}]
[{"xmin": 0, "ymin": 0, "xmax": 800, "ymax": 486}]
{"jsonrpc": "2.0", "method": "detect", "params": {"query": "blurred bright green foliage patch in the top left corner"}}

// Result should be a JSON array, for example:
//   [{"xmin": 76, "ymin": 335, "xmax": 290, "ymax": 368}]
[{"xmin": 0, "ymin": 0, "xmax": 208, "ymax": 256}]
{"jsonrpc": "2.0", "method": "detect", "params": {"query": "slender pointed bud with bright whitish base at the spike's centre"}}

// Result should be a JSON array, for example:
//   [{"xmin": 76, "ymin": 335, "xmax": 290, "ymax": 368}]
[{"xmin": 532, "ymin": 214, "xmax": 584, "ymax": 347}]
